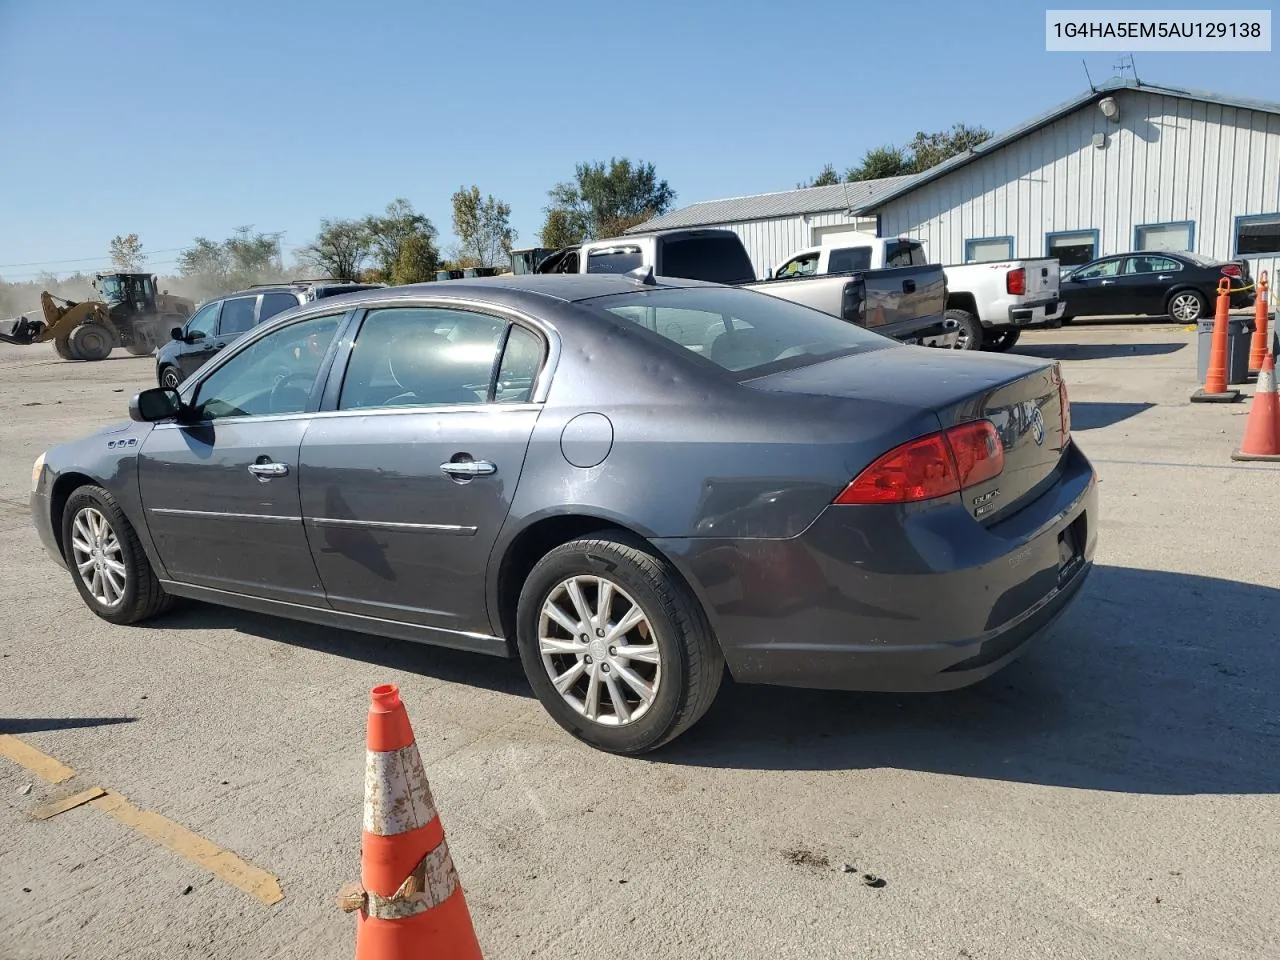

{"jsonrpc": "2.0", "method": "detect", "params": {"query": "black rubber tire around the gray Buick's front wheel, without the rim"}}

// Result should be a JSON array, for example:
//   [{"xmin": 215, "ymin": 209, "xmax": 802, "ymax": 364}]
[{"xmin": 61, "ymin": 486, "xmax": 173, "ymax": 623}]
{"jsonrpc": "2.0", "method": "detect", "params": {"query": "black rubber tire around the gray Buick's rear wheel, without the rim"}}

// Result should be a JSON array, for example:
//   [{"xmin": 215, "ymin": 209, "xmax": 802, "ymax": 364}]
[{"xmin": 516, "ymin": 531, "xmax": 724, "ymax": 755}]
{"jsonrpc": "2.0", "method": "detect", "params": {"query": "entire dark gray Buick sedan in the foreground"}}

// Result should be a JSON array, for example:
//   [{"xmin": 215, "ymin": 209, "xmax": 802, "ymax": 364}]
[{"xmin": 31, "ymin": 275, "xmax": 1097, "ymax": 753}]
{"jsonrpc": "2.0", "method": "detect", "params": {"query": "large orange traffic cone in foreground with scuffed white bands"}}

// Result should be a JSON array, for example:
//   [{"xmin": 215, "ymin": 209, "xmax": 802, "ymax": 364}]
[{"xmin": 338, "ymin": 684, "xmax": 483, "ymax": 960}]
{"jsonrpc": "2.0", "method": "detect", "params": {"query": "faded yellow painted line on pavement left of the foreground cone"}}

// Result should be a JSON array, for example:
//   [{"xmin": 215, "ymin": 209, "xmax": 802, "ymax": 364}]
[{"xmin": 0, "ymin": 733, "xmax": 284, "ymax": 906}]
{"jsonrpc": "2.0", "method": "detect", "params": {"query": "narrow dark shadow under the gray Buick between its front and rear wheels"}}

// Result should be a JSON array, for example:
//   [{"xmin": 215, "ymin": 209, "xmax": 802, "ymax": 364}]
[{"xmin": 136, "ymin": 609, "xmax": 534, "ymax": 698}]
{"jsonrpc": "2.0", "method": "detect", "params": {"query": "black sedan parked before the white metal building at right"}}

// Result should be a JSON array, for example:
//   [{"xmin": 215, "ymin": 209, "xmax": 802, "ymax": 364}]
[{"xmin": 1059, "ymin": 251, "xmax": 1256, "ymax": 324}]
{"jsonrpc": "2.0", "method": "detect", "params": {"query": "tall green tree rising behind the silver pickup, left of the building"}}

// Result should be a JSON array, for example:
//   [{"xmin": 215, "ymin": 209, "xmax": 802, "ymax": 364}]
[{"xmin": 543, "ymin": 157, "xmax": 676, "ymax": 243}]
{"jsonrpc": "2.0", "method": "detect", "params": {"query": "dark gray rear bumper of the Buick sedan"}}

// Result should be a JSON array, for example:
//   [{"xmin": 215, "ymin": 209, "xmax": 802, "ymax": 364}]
[{"xmin": 658, "ymin": 444, "xmax": 1098, "ymax": 692}]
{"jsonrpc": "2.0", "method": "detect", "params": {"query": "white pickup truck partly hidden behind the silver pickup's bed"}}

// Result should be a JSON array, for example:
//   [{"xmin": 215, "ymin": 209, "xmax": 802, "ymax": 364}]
[{"xmin": 769, "ymin": 230, "xmax": 1066, "ymax": 351}]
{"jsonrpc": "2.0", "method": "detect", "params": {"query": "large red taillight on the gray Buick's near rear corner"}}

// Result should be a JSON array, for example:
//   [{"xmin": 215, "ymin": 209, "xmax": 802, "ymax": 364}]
[{"xmin": 835, "ymin": 420, "xmax": 1005, "ymax": 506}]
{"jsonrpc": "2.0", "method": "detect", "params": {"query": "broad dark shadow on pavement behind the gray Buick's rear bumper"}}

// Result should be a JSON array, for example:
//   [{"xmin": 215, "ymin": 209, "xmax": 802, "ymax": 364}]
[{"xmin": 650, "ymin": 566, "xmax": 1280, "ymax": 795}]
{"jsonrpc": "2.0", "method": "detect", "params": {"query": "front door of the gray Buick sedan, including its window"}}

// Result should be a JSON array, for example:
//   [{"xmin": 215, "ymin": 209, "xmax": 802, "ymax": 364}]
[{"xmin": 138, "ymin": 311, "xmax": 348, "ymax": 605}]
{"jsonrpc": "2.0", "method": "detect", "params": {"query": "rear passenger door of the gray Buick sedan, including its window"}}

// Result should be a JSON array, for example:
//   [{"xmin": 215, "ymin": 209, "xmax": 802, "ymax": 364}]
[{"xmin": 301, "ymin": 306, "xmax": 547, "ymax": 635}]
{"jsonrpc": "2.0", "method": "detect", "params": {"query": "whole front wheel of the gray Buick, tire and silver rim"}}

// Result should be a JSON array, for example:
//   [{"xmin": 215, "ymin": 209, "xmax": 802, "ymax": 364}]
[{"xmin": 63, "ymin": 486, "xmax": 173, "ymax": 623}]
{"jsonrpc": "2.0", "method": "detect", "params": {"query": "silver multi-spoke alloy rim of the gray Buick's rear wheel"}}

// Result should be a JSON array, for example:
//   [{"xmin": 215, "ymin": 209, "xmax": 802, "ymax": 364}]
[{"xmin": 538, "ymin": 575, "xmax": 662, "ymax": 727}]
